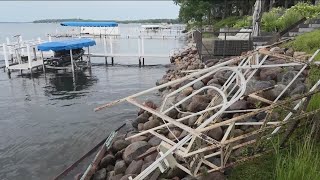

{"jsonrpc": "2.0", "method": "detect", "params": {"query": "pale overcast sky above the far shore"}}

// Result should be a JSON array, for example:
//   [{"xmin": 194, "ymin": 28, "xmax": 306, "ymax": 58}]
[{"xmin": 0, "ymin": 0, "xmax": 179, "ymax": 22}]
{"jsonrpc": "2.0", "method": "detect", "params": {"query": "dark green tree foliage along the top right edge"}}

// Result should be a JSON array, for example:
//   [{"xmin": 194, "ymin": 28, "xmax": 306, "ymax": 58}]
[{"xmin": 173, "ymin": 0, "xmax": 317, "ymax": 24}]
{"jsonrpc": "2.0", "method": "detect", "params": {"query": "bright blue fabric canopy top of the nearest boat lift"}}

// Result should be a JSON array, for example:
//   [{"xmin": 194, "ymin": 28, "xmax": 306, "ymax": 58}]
[{"xmin": 38, "ymin": 38, "xmax": 96, "ymax": 51}]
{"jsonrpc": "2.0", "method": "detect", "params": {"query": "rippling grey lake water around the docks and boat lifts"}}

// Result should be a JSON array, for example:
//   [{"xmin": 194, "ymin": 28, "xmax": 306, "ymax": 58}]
[{"xmin": 0, "ymin": 23, "xmax": 185, "ymax": 180}]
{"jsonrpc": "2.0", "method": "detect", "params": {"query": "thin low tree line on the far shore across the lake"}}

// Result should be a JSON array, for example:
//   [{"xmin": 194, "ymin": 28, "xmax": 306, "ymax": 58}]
[{"xmin": 33, "ymin": 18, "xmax": 180, "ymax": 24}]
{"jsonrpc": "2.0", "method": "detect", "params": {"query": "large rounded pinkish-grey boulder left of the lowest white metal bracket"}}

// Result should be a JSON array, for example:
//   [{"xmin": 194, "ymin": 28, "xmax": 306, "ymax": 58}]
[{"xmin": 122, "ymin": 141, "xmax": 151, "ymax": 164}]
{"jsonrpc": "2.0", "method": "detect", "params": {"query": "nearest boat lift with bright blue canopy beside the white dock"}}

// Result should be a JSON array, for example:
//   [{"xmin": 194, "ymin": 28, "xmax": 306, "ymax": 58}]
[{"xmin": 38, "ymin": 38, "xmax": 96, "ymax": 75}]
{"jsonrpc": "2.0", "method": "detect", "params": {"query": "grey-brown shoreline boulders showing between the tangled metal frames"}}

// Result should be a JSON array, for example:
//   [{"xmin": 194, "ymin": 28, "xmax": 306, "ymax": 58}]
[{"xmin": 82, "ymin": 38, "xmax": 309, "ymax": 180}]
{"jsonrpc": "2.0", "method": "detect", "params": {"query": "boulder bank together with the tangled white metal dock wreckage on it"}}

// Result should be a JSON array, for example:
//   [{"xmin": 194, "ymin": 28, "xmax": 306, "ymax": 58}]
[{"xmin": 79, "ymin": 38, "xmax": 320, "ymax": 180}]
